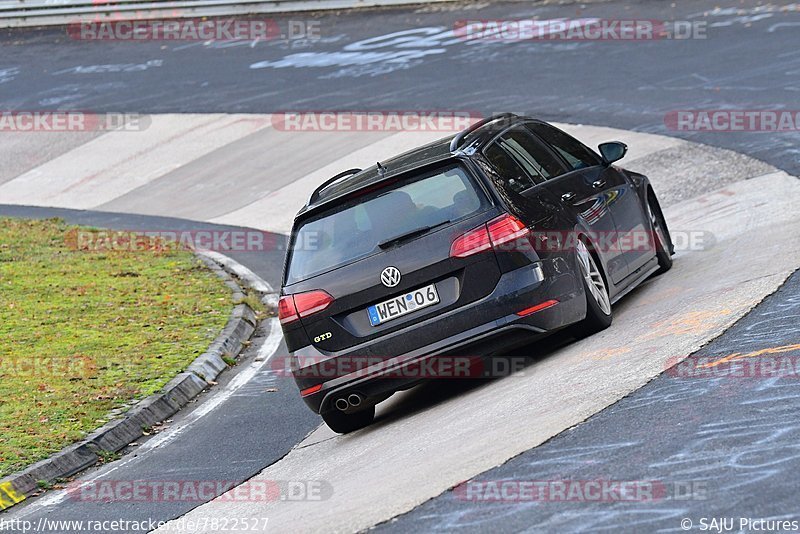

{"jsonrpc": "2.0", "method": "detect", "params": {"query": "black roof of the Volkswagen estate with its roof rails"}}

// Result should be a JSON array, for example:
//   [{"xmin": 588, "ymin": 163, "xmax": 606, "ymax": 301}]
[{"xmin": 295, "ymin": 113, "xmax": 534, "ymax": 219}]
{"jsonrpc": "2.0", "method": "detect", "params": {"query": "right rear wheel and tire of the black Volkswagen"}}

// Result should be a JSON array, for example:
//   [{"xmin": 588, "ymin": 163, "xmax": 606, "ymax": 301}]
[{"xmin": 571, "ymin": 240, "xmax": 613, "ymax": 339}]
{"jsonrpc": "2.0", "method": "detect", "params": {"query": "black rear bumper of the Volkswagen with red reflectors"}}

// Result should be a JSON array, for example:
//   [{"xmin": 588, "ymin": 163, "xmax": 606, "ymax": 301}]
[{"xmin": 294, "ymin": 266, "xmax": 586, "ymax": 413}]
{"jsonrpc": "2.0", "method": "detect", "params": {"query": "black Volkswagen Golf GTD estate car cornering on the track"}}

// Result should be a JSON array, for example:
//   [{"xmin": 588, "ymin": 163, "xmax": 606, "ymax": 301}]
[{"xmin": 279, "ymin": 114, "xmax": 673, "ymax": 433}]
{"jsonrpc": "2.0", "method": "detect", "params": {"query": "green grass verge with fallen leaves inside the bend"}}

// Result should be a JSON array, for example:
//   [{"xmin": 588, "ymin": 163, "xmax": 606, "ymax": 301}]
[{"xmin": 0, "ymin": 218, "xmax": 232, "ymax": 477}]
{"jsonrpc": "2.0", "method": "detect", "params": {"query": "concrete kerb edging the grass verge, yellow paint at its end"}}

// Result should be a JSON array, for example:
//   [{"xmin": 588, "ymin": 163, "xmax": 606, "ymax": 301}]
[{"xmin": 0, "ymin": 252, "xmax": 264, "ymax": 511}]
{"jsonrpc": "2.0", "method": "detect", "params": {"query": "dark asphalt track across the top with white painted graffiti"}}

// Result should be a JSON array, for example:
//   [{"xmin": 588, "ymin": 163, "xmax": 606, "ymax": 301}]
[{"xmin": 0, "ymin": 0, "xmax": 800, "ymax": 175}]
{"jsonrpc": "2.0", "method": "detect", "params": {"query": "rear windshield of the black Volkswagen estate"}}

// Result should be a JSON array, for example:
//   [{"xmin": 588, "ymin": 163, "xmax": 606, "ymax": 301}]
[{"xmin": 285, "ymin": 165, "xmax": 485, "ymax": 285}]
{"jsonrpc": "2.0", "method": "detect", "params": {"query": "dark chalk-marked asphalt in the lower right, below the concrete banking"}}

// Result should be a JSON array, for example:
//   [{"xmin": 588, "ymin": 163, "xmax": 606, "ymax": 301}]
[{"xmin": 375, "ymin": 272, "xmax": 800, "ymax": 532}]
